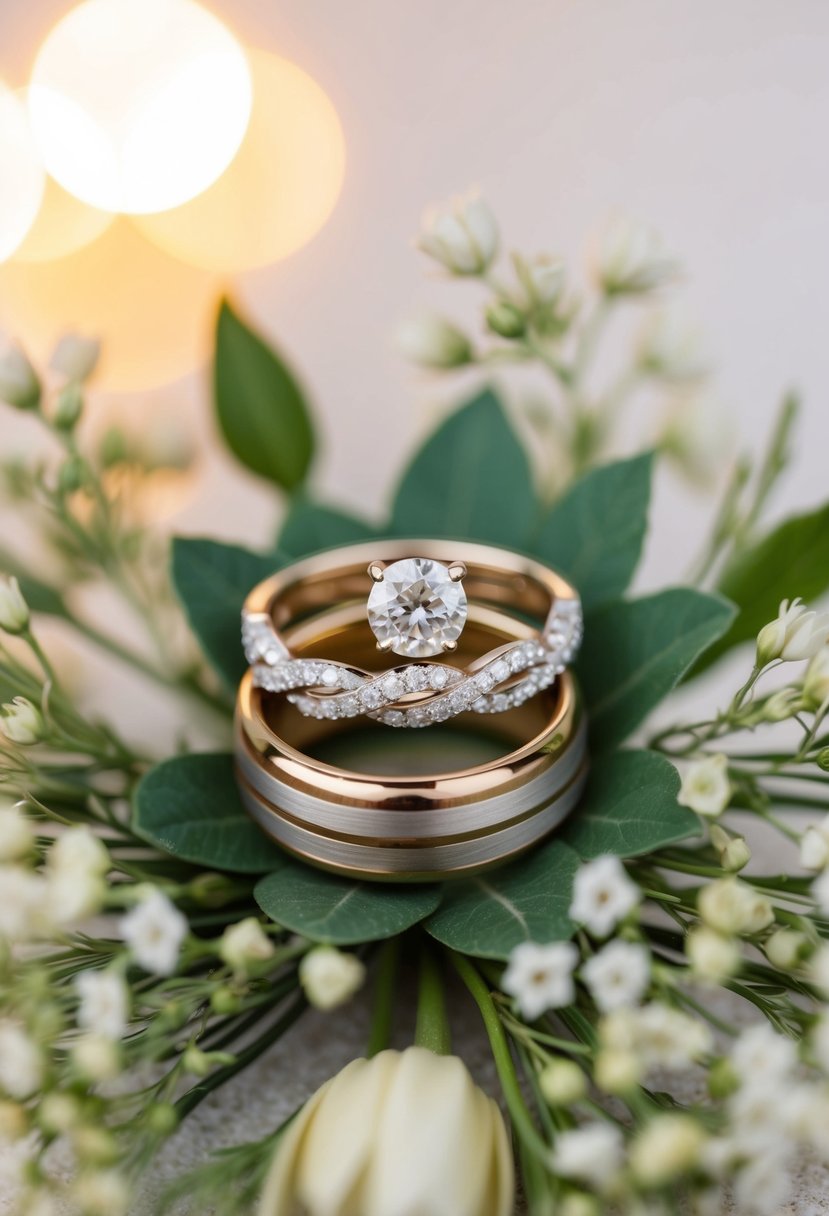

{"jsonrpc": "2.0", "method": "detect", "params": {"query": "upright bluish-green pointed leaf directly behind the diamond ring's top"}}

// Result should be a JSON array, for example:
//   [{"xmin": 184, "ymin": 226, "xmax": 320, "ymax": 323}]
[{"xmin": 391, "ymin": 389, "xmax": 537, "ymax": 548}]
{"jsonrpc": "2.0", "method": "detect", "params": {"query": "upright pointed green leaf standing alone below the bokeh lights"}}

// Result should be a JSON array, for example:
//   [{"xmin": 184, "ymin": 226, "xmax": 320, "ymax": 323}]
[{"xmin": 214, "ymin": 300, "xmax": 314, "ymax": 490}]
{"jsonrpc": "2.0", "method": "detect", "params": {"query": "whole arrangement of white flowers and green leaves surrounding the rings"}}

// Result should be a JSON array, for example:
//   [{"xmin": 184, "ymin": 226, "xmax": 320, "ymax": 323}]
[{"xmin": 0, "ymin": 189, "xmax": 829, "ymax": 1216}]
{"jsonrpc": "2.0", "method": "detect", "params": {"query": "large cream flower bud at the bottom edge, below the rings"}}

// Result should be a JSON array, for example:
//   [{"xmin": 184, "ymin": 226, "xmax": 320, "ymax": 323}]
[{"xmin": 259, "ymin": 1047, "xmax": 514, "ymax": 1216}]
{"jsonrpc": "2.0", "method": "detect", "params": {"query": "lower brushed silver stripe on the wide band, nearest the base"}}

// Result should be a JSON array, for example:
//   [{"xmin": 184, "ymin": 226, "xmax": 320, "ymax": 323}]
[{"xmin": 239, "ymin": 766, "xmax": 587, "ymax": 878}]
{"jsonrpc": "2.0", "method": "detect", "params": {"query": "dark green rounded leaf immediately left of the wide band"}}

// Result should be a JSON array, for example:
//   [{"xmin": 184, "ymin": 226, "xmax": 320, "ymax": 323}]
[{"xmin": 132, "ymin": 753, "xmax": 282, "ymax": 874}]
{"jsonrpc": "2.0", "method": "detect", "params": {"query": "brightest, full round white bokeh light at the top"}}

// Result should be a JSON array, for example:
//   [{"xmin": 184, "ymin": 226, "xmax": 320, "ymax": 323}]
[{"xmin": 29, "ymin": 0, "xmax": 252, "ymax": 213}]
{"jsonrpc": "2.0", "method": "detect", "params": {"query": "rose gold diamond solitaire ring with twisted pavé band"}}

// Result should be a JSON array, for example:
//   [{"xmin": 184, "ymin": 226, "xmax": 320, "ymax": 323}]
[{"xmin": 242, "ymin": 540, "xmax": 582, "ymax": 726}]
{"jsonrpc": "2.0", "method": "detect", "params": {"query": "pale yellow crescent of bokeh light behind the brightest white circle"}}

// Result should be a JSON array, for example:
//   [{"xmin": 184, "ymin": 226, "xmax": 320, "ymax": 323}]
[{"xmin": 136, "ymin": 50, "xmax": 345, "ymax": 271}]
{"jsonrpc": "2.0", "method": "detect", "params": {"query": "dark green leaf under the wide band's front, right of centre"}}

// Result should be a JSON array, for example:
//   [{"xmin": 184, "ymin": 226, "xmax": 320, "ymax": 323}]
[{"xmin": 425, "ymin": 840, "xmax": 580, "ymax": 958}]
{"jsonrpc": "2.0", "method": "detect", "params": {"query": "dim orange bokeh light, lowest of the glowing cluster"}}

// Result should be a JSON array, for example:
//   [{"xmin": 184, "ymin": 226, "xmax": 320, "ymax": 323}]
[{"xmin": 0, "ymin": 218, "xmax": 219, "ymax": 390}]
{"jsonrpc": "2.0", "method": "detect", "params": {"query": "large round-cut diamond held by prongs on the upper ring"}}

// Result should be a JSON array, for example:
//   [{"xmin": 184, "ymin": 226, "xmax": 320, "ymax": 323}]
[{"xmin": 367, "ymin": 557, "xmax": 467, "ymax": 659}]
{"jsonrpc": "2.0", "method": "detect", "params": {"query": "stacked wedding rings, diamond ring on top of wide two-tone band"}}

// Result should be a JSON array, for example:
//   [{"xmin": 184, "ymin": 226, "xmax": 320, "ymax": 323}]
[{"xmin": 235, "ymin": 541, "xmax": 587, "ymax": 880}]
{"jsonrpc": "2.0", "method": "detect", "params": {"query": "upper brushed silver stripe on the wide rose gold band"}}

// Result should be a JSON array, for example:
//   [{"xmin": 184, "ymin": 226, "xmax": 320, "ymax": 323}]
[{"xmin": 236, "ymin": 717, "xmax": 587, "ymax": 839}]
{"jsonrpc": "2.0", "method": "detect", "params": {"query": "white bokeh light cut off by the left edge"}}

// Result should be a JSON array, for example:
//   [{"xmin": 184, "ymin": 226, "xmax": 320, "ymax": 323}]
[{"xmin": 0, "ymin": 83, "xmax": 45, "ymax": 261}]
